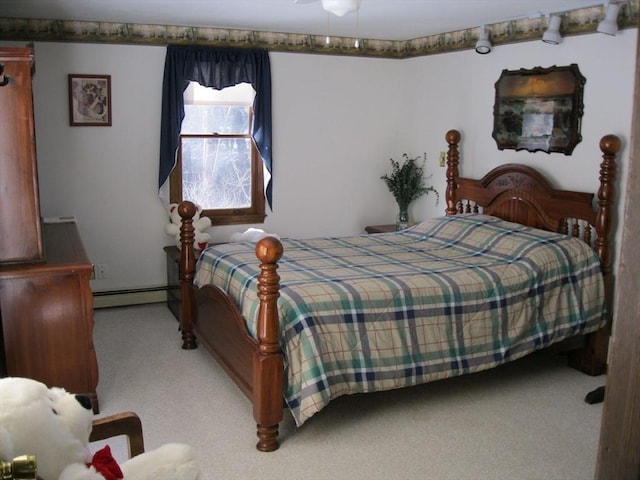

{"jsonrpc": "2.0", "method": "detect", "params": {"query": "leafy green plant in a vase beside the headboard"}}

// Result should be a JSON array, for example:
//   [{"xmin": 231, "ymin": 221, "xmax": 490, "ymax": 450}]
[{"xmin": 380, "ymin": 153, "xmax": 440, "ymax": 230}]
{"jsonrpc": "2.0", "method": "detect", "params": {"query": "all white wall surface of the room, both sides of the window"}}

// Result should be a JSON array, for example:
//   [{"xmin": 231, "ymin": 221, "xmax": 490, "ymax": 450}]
[{"xmin": 0, "ymin": 29, "xmax": 637, "ymax": 291}]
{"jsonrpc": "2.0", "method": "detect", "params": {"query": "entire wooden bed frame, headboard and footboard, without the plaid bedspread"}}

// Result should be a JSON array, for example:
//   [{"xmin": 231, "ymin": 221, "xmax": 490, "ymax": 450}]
[{"xmin": 178, "ymin": 130, "xmax": 620, "ymax": 452}]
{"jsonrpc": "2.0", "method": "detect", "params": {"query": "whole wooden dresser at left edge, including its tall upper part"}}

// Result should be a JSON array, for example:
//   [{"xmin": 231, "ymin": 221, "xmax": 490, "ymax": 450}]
[{"xmin": 0, "ymin": 47, "xmax": 99, "ymax": 413}]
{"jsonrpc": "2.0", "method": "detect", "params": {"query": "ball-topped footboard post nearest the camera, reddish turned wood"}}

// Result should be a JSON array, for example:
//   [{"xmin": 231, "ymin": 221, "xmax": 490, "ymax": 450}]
[{"xmin": 253, "ymin": 237, "xmax": 284, "ymax": 452}]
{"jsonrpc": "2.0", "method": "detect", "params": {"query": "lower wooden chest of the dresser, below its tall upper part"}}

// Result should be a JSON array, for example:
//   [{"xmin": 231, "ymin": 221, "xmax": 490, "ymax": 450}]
[{"xmin": 0, "ymin": 223, "xmax": 98, "ymax": 412}]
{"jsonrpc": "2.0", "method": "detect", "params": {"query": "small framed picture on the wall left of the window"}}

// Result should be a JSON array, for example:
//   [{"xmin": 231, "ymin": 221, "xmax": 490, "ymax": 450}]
[{"xmin": 69, "ymin": 74, "xmax": 111, "ymax": 127}]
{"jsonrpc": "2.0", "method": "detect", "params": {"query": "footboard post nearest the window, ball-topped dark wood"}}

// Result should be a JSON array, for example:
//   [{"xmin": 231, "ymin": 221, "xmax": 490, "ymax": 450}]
[{"xmin": 177, "ymin": 201, "xmax": 197, "ymax": 350}]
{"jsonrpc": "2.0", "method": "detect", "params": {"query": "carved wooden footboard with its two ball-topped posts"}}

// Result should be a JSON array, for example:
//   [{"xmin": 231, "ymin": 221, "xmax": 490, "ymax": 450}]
[{"xmin": 178, "ymin": 202, "xmax": 284, "ymax": 452}]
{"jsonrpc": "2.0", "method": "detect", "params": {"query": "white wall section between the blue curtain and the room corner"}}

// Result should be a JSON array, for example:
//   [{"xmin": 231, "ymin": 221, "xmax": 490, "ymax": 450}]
[{"xmin": 245, "ymin": 53, "xmax": 401, "ymax": 237}]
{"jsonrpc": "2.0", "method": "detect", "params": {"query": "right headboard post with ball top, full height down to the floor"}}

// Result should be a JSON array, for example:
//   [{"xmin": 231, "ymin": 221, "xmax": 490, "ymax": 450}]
[{"xmin": 569, "ymin": 135, "xmax": 620, "ymax": 375}]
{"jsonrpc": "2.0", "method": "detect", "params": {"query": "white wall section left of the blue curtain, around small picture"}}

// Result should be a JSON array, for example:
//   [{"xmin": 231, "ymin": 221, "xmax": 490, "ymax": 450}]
[{"xmin": 27, "ymin": 43, "xmax": 168, "ymax": 290}]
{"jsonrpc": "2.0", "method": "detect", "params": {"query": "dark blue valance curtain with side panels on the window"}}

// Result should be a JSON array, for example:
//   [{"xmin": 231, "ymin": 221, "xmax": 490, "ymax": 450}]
[{"xmin": 158, "ymin": 45, "xmax": 273, "ymax": 208}]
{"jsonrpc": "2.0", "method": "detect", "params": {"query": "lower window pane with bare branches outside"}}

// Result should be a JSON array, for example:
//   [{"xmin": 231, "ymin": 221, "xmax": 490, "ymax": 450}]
[{"xmin": 182, "ymin": 137, "xmax": 251, "ymax": 209}]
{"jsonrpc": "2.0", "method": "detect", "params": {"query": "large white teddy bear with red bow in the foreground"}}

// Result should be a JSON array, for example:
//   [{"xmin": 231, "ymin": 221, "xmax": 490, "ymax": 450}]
[{"xmin": 0, "ymin": 377, "xmax": 199, "ymax": 480}]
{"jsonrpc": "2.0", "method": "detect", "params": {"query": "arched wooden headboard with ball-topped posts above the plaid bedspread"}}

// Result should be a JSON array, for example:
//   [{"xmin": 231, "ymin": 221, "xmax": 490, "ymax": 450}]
[{"xmin": 445, "ymin": 130, "xmax": 620, "ymax": 273}]
